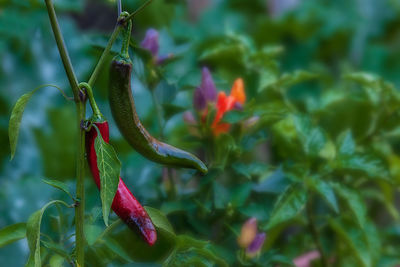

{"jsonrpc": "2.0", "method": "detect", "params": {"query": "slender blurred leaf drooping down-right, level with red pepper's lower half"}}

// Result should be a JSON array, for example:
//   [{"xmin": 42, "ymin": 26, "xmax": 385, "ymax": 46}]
[{"xmin": 332, "ymin": 184, "xmax": 367, "ymax": 228}]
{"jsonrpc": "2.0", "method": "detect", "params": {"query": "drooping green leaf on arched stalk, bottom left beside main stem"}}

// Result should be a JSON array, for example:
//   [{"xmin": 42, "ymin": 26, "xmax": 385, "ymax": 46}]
[{"xmin": 26, "ymin": 200, "xmax": 69, "ymax": 267}]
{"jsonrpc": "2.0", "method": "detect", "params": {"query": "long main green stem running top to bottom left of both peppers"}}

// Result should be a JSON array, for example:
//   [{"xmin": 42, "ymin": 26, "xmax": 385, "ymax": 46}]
[{"xmin": 45, "ymin": 0, "xmax": 86, "ymax": 267}]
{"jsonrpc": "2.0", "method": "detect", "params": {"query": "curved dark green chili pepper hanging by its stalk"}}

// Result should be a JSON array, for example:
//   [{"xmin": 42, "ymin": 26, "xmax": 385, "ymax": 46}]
[{"xmin": 109, "ymin": 18, "xmax": 207, "ymax": 174}]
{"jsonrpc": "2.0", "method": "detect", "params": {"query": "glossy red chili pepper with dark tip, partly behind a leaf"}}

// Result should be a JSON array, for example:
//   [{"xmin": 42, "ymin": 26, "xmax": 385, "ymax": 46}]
[{"xmin": 86, "ymin": 120, "xmax": 157, "ymax": 246}]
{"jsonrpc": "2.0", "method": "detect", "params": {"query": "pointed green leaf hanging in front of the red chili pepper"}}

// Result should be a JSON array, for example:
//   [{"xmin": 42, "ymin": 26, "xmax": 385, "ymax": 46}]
[{"xmin": 94, "ymin": 134, "xmax": 121, "ymax": 226}]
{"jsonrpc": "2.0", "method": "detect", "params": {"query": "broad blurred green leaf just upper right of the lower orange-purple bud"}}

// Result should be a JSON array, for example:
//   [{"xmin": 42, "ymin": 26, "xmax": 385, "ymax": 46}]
[{"xmin": 266, "ymin": 185, "xmax": 307, "ymax": 229}]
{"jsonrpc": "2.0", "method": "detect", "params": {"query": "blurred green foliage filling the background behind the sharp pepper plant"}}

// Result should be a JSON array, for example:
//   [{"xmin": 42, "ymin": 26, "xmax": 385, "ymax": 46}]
[{"xmin": 0, "ymin": 0, "xmax": 400, "ymax": 267}]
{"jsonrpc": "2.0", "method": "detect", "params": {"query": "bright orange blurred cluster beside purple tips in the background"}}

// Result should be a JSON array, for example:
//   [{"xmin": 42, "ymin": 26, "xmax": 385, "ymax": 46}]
[{"xmin": 211, "ymin": 78, "xmax": 246, "ymax": 136}]
